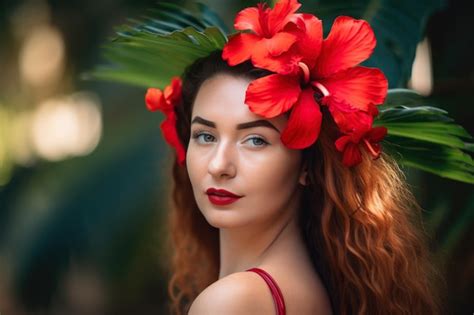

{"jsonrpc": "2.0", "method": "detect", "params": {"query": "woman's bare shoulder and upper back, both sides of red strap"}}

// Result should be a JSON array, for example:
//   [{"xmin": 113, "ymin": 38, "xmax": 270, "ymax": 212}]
[{"xmin": 188, "ymin": 268, "xmax": 332, "ymax": 315}]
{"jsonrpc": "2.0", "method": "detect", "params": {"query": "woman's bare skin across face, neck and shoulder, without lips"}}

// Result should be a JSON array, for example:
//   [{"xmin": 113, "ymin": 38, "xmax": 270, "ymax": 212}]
[{"xmin": 186, "ymin": 74, "xmax": 330, "ymax": 315}]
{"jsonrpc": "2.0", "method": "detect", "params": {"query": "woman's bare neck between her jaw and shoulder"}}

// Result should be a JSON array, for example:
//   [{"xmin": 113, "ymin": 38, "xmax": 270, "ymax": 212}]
[{"xmin": 219, "ymin": 194, "xmax": 302, "ymax": 279}]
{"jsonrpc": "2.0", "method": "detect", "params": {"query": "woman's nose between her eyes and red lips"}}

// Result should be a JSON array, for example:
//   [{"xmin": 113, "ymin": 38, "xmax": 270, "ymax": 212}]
[{"xmin": 208, "ymin": 141, "xmax": 237, "ymax": 179}]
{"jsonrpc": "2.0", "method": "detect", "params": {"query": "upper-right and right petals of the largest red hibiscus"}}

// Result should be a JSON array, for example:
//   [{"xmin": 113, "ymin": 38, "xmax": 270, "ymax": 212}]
[{"xmin": 311, "ymin": 16, "xmax": 388, "ymax": 112}]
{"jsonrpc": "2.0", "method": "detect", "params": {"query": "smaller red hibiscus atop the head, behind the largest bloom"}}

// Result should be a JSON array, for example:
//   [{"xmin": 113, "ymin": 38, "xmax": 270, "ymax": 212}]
[{"xmin": 222, "ymin": 0, "xmax": 301, "ymax": 73}]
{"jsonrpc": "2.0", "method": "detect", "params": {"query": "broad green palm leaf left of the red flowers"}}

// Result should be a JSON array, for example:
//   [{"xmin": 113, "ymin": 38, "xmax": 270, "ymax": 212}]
[{"xmin": 89, "ymin": 3, "xmax": 227, "ymax": 88}]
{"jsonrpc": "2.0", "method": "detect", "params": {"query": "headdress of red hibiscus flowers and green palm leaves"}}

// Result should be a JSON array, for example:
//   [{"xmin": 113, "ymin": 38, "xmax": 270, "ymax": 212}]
[{"xmin": 94, "ymin": 0, "xmax": 474, "ymax": 183}]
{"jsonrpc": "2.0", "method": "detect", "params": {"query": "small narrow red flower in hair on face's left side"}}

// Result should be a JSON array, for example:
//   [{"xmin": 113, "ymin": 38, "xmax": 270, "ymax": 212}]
[{"xmin": 145, "ymin": 77, "xmax": 186, "ymax": 166}]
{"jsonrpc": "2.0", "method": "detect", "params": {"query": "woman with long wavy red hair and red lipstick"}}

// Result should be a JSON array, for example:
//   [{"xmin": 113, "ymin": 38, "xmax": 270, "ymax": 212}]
[{"xmin": 153, "ymin": 51, "xmax": 444, "ymax": 314}]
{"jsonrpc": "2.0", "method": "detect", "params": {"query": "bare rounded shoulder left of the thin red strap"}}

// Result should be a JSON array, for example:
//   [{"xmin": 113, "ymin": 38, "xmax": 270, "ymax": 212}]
[{"xmin": 189, "ymin": 272, "xmax": 275, "ymax": 315}]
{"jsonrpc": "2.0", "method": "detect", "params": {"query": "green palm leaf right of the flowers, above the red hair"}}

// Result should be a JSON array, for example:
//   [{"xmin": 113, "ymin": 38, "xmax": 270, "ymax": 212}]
[{"xmin": 374, "ymin": 90, "xmax": 474, "ymax": 184}]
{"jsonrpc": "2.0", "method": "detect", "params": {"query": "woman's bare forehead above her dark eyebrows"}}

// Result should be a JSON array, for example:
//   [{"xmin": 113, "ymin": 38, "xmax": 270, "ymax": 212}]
[{"xmin": 192, "ymin": 73, "xmax": 287, "ymax": 130}]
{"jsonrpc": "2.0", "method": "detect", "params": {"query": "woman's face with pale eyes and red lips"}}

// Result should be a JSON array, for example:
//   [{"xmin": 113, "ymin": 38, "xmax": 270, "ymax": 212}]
[{"xmin": 186, "ymin": 74, "xmax": 305, "ymax": 228}]
